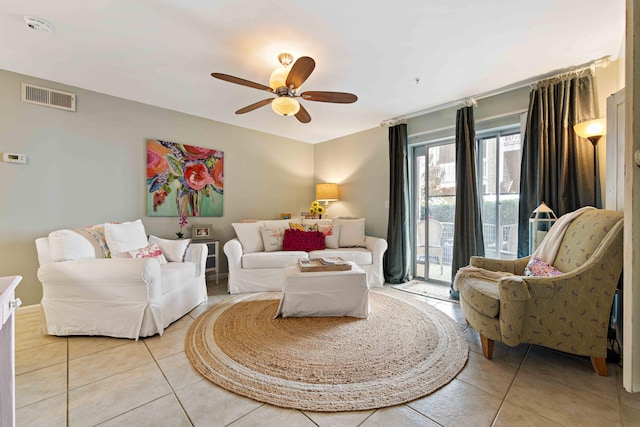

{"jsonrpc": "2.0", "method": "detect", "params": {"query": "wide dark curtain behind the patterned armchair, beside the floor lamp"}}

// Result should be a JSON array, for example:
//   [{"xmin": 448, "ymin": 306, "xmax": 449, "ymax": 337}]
[{"xmin": 518, "ymin": 70, "xmax": 599, "ymax": 258}]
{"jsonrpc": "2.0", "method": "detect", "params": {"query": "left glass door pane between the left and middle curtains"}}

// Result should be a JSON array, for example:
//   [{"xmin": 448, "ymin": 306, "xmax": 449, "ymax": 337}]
[{"xmin": 412, "ymin": 140, "xmax": 456, "ymax": 282}]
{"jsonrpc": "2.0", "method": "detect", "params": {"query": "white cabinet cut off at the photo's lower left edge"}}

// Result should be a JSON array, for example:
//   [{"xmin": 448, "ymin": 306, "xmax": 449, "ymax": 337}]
[{"xmin": 0, "ymin": 276, "xmax": 22, "ymax": 427}]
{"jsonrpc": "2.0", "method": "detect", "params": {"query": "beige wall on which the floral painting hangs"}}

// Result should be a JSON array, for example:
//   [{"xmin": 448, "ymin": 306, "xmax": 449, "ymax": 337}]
[{"xmin": 0, "ymin": 70, "xmax": 314, "ymax": 305}]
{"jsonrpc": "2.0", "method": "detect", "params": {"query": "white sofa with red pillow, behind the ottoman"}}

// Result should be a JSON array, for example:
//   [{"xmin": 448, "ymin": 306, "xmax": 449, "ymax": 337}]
[{"xmin": 224, "ymin": 218, "xmax": 387, "ymax": 294}]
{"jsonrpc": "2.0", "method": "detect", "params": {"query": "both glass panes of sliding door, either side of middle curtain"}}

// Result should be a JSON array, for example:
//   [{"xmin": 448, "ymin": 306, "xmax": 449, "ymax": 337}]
[{"xmin": 411, "ymin": 125, "xmax": 522, "ymax": 283}]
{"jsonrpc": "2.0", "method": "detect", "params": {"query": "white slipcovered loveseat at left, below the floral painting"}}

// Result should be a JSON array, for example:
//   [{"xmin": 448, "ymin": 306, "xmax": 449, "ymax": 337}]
[{"xmin": 36, "ymin": 220, "xmax": 207, "ymax": 339}]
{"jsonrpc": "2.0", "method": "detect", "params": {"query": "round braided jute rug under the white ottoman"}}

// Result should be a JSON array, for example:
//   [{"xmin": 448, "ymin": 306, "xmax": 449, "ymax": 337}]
[{"xmin": 185, "ymin": 290, "xmax": 469, "ymax": 412}]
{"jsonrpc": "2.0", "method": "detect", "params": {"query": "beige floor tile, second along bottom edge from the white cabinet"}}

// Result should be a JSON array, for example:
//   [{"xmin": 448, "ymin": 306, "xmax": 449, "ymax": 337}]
[{"xmin": 69, "ymin": 363, "xmax": 171, "ymax": 426}]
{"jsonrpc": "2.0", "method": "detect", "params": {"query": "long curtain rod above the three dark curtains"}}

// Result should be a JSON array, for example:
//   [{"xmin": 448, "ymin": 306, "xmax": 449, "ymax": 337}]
[{"xmin": 380, "ymin": 55, "xmax": 611, "ymax": 127}]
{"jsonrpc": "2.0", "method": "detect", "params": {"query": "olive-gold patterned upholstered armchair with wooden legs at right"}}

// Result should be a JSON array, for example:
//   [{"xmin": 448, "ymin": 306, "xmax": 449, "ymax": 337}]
[{"xmin": 454, "ymin": 209, "xmax": 623, "ymax": 376}]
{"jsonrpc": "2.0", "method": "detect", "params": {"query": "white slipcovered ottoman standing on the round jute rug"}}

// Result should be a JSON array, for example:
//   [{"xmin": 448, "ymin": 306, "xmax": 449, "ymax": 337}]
[{"xmin": 276, "ymin": 263, "xmax": 369, "ymax": 318}]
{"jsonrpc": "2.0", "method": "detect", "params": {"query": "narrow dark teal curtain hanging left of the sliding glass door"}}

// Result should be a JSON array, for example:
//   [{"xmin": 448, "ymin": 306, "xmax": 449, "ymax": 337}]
[{"xmin": 384, "ymin": 123, "xmax": 411, "ymax": 284}]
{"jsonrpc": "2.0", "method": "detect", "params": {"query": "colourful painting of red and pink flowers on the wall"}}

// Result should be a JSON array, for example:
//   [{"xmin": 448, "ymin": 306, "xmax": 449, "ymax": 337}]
[{"xmin": 147, "ymin": 139, "xmax": 224, "ymax": 217}]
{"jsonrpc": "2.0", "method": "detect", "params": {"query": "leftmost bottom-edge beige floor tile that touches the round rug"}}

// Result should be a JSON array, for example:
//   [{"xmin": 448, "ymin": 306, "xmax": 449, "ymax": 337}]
[{"xmin": 175, "ymin": 380, "xmax": 263, "ymax": 427}]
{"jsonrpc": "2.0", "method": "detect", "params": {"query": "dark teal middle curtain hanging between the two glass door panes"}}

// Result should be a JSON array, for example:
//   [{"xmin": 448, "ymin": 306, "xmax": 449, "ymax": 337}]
[{"xmin": 450, "ymin": 107, "xmax": 484, "ymax": 299}]
